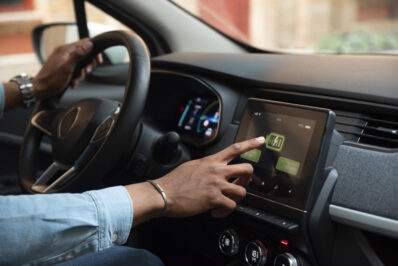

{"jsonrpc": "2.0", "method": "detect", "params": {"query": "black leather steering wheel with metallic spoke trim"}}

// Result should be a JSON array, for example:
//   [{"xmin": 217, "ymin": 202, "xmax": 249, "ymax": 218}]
[{"xmin": 18, "ymin": 31, "xmax": 150, "ymax": 193}]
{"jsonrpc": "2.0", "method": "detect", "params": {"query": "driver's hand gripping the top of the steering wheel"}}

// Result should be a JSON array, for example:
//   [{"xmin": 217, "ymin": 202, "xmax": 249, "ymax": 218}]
[{"xmin": 32, "ymin": 38, "xmax": 102, "ymax": 99}]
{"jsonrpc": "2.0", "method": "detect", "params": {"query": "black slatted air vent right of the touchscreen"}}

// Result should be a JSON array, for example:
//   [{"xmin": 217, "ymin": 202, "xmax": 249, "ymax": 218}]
[{"xmin": 335, "ymin": 111, "xmax": 398, "ymax": 148}]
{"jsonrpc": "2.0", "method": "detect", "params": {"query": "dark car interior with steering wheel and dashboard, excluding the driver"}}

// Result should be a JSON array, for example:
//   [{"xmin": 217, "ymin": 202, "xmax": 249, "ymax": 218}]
[{"xmin": 0, "ymin": 0, "xmax": 398, "ymax": 266}]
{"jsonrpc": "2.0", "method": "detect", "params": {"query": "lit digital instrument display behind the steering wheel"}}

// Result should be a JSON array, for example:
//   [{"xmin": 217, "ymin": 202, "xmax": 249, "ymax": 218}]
[{"xmin": 178, "ymin": 97, "xmax": 220, "ymax": 144}]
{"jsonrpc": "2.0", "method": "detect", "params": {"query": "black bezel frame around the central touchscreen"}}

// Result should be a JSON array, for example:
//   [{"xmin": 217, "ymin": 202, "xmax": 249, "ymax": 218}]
[{"xmin": 235, "ymin": 98, "xmax": 331, "ymax": 211}]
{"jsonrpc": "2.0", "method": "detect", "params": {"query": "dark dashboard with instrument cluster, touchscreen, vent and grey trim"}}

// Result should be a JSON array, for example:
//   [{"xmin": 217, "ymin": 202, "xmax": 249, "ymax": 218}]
[{"xmin": 115, "ymin": 54, "xmax": 398, "ymax": 265}]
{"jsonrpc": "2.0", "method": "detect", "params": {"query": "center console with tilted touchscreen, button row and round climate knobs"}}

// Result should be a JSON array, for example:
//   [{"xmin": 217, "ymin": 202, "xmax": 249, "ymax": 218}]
[{"xmin": 218, "ymin": 98, "xmax": 337, "ymax": 265}]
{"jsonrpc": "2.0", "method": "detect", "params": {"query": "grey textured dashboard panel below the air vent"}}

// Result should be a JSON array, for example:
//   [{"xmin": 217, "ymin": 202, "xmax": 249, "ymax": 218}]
[{"xmin": 332, "ymin": 145, "xmax": 398, "ymax": 220}]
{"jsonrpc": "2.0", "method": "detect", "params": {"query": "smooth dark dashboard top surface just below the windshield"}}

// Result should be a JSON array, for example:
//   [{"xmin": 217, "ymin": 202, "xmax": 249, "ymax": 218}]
[{"xmin": 152, "ymin": 53, "xmax": 398, "ymax": 105}]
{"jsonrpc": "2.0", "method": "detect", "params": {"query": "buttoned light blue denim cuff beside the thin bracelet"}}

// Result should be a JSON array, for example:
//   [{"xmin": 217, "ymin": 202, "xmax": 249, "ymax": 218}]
[{"xmin": 85, "ymin": 186, "xmax": 133, "ymax": 250}]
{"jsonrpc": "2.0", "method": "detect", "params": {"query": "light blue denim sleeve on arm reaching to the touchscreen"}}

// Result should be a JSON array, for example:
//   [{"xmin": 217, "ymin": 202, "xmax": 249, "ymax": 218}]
[{"xmin": 0, "ymin": 186, "xmax": 133, "ymax": 265}]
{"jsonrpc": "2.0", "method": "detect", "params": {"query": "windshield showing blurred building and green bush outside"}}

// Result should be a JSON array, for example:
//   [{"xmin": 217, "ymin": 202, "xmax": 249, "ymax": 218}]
[{"xmin": 172, "ymin": 0, "xmax": 398, "ymax": 54}]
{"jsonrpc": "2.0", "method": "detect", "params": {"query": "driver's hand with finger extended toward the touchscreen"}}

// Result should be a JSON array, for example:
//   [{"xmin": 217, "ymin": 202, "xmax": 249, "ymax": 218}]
[{"xmin": 155, "ymin": 137, "xmax": 265, "ymax": 217}]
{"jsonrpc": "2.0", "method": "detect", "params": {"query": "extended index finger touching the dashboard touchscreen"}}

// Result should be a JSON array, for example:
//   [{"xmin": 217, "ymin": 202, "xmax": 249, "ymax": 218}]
[{"xmin": 215, "ymin": 136, "xmax": 265, "ymax": 163}]
